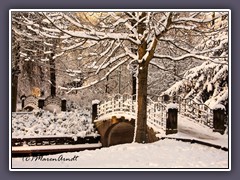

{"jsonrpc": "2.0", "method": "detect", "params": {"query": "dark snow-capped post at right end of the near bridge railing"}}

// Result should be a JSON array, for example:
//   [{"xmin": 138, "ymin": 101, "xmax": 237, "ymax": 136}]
[{"xmin": 166, "ymin": 103, "xmax": 178, "ymax": 135}]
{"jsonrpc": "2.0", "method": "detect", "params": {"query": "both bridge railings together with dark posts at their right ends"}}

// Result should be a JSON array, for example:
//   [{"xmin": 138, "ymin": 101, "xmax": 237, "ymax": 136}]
[{"xmin": 96, "ymin": 94, "xmax": 225, "ymax": 133}]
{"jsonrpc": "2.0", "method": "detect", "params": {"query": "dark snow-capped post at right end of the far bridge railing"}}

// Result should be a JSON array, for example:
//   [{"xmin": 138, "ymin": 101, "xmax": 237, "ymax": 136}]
[{"xmin": 213, "ymin": 105, "xmax": 225, "ymax": 134}]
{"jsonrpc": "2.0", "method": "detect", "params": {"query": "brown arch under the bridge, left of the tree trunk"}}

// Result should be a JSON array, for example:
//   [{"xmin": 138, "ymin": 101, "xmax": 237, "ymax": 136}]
[{"xmin": 103, "ymin": 121, "xmax": 134, "ymax": 146}]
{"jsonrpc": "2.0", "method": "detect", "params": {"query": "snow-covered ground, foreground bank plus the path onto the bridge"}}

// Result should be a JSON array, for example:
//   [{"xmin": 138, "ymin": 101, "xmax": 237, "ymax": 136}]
[{"xmin": 12, "ymin": 112, "xmax": 230, "ymax": 170}]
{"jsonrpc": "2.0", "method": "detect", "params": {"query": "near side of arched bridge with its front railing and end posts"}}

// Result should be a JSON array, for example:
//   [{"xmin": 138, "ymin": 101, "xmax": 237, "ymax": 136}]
[{"xmin": 92, "ymin": 94, "xmax": 177, "ymax": 146}]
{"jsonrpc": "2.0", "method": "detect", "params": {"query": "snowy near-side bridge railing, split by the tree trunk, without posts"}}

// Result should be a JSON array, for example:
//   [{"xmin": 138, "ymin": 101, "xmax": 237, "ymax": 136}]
[{"xmin": 97, "ymin": 94, "xmax": 167, "ymax": 130}]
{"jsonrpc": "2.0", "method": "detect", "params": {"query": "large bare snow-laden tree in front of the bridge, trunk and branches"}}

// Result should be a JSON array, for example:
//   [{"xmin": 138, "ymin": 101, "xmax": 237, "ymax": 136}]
[{"xmin": 12, "ymin": 11, "xmax": 228, "ymax": 143}]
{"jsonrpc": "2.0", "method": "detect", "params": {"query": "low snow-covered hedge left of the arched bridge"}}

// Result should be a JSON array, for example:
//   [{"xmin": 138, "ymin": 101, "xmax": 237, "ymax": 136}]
[{"xmin": 12, "ymin": 110, "xmax": 98, "ymax": 138}]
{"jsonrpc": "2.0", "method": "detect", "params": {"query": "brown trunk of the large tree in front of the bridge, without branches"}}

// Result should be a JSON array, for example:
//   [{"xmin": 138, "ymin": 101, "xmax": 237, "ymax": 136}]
[{"xmin": 135, "ymin": 62, "xmax": 148, "ymax": 143}]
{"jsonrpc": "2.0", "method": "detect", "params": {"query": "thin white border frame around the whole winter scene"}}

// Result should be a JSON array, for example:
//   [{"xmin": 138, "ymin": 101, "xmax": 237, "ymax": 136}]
[{"xmin": 9, "ymin": 9, "xmax": 232, "ymax": 171}]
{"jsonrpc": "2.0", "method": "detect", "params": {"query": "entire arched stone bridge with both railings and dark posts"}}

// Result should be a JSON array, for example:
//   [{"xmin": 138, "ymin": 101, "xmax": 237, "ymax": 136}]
[{"xmin": 92, "ymin": 94, "xmax": 227, "ymax": 146}]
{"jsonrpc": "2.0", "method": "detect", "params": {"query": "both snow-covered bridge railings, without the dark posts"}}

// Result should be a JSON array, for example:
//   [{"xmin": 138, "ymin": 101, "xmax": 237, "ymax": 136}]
[{"xmin": 97, "ymin": 94, "xmax": 226, "ymax": 134}]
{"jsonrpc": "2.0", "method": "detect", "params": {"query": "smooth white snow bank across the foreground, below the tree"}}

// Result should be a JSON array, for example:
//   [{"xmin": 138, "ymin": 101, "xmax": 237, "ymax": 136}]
[{"xmin": 12, "ymin": 140, "xmax": 228, "ymax": 168}]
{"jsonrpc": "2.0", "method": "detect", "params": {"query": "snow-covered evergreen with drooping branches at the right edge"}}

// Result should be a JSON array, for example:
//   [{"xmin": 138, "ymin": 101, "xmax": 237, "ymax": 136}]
[{"xmin": 163, "ymin": 13, "xmax": 229, "ymax": 109}]
